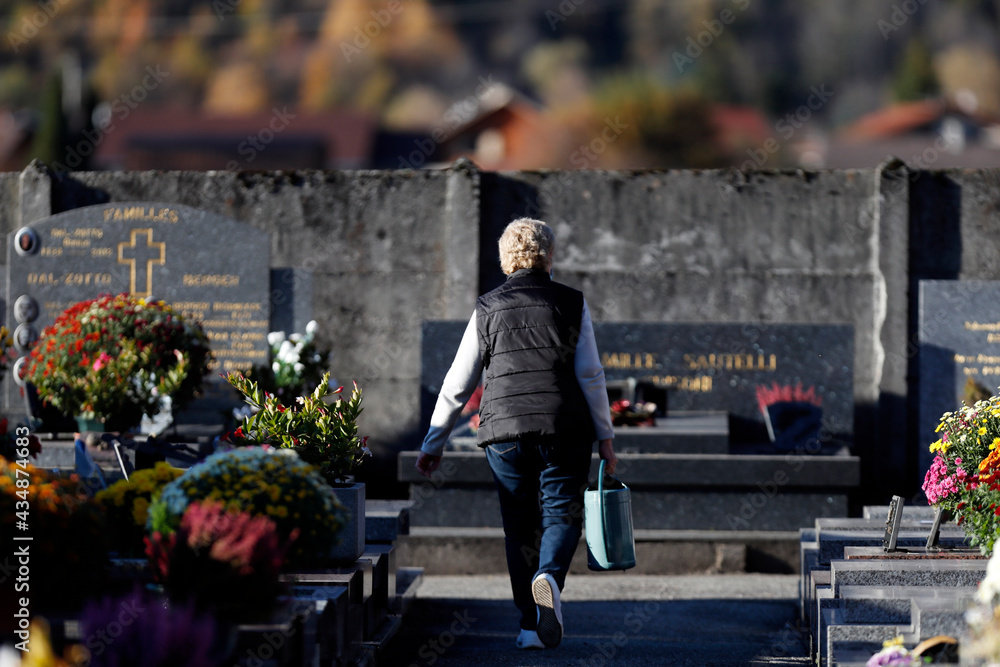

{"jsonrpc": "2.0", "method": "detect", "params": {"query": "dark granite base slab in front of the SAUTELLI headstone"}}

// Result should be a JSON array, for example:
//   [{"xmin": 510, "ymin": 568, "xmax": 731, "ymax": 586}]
[{"xmin": 398, "ymin": 452, "xmax": 859, "ymax": 531}]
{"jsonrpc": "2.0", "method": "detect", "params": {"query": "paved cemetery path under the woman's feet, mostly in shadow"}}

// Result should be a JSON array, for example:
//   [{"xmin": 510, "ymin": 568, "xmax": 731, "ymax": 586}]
[{"xmin": 378, "ymin": 573, "xmax": 809, "ymax": 667}]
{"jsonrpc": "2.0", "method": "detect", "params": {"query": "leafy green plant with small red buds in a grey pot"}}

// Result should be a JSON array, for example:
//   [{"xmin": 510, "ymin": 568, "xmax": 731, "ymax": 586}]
[{"xmin": 224, "ymin": 372, "xmax": 371, "ymax": 562}]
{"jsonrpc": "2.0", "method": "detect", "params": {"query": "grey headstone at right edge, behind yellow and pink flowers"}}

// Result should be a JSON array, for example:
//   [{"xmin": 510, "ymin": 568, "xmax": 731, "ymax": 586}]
[{"xmin": 917, "ymin": 280, "xmax": 1000, "ymax": 480}]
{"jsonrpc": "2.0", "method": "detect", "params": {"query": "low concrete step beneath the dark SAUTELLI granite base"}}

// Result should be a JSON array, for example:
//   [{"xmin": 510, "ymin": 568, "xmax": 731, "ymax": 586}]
[{"xmin": 396, "ymin": 526, "xmax": 798, "ymax": 575}]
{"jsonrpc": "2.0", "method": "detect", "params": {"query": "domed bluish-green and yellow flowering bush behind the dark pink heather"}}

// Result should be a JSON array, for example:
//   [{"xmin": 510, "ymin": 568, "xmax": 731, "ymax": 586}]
[{"xmin": 148, "ymin": 447, "xmax": 347, "ymax": 563}]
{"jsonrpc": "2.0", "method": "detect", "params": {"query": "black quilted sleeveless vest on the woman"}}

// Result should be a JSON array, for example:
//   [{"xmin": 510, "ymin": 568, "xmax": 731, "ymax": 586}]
[{"xmin": 476, "ymin": 269, "xmax": 597, "ymax": 447}]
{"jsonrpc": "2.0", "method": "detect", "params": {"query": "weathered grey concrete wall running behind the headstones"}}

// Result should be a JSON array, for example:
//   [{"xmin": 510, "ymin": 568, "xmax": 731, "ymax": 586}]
[{"xmin": 0, "ymin": 161, "xmax": 1000, "ymax": 498}]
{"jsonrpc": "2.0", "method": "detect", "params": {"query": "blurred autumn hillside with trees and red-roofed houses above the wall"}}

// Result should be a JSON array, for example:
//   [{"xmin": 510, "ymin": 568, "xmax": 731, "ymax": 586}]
[{"xmin": 0, "ymin": 0, "xmax": 1000, "ymax": 175}]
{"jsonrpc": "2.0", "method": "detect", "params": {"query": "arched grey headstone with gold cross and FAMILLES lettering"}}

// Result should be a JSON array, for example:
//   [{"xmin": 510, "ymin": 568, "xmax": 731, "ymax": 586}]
[{"xmin": 6, "ymin": 202, "xmax": 271, "ymax": 408}]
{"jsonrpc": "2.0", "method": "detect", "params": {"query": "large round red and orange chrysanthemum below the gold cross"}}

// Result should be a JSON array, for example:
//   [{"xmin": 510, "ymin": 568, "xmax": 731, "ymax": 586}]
[{"xmin": 24, "ymin": 294, "xmax": 211, "ymax": 430}]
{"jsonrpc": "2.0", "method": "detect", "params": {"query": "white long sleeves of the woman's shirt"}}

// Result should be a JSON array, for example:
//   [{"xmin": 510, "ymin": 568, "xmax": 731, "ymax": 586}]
[{"xmin": 420, "ymin": 300, "xmax": 615, "ymax": 456}]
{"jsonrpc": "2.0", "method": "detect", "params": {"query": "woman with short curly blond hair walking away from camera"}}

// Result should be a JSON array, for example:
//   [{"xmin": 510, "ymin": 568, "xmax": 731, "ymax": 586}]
[{"xmin": 416, "ymin": 218, "xmax": 617, "ymax": 648}]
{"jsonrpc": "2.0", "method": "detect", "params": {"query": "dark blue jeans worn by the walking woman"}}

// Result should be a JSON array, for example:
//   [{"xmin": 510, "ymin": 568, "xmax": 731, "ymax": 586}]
[{"xmin": 486, "ymin": 439, "xmax": 593, "ymax": 630}]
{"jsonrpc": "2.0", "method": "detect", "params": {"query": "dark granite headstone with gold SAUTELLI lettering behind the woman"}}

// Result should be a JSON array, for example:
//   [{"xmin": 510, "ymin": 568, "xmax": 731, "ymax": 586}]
[{"xmin": 421, "ymin": 320, "xmax": 854, "ymax": 446}]
